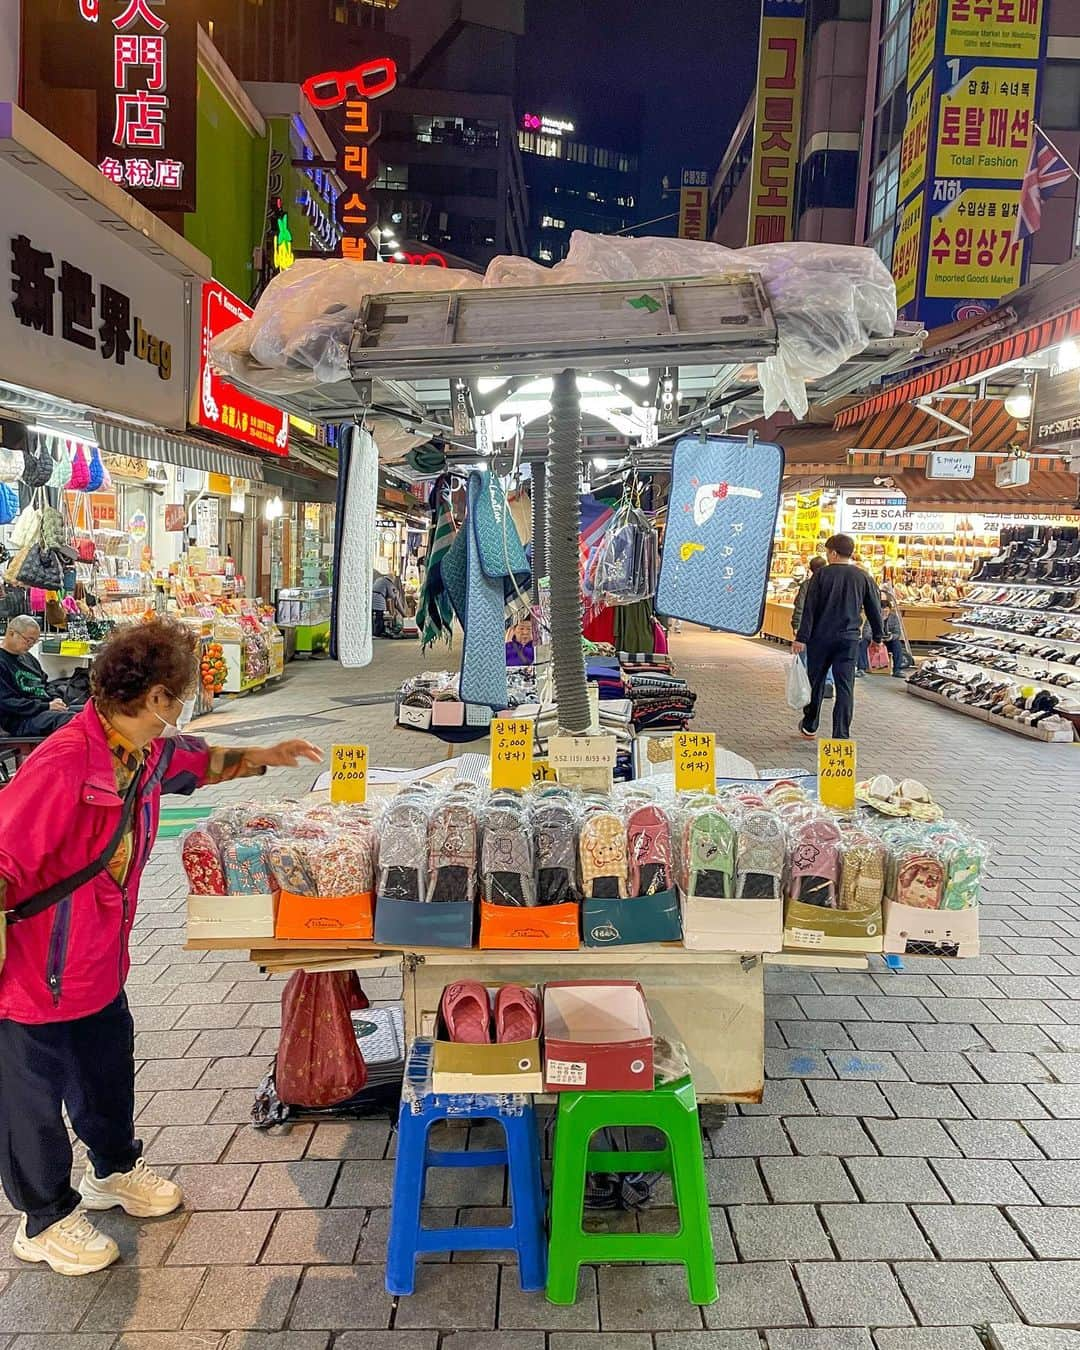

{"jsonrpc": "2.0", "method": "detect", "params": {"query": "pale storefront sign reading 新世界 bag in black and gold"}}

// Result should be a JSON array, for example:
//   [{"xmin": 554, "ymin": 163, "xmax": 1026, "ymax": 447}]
[{"xmin": 0, "ymin": 147, "xmax": 188, "ymax": 427}]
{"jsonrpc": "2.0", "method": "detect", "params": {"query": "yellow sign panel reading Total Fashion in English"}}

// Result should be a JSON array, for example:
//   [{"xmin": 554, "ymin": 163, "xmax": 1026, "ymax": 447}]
[{"xmin": 934, "ymin": 66, "xmax": 1037, "ymax": 178}]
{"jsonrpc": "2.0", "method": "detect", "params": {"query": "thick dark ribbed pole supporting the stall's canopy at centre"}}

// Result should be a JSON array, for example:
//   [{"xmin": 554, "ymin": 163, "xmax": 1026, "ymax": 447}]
[{"xmin": 548, "ymin": 370, "xmax": 591, "ymax": 736}]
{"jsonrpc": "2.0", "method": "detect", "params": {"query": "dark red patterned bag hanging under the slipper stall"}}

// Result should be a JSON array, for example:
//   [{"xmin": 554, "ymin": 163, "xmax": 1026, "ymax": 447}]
[{"xmin": 275, "ymin": 971, "xmax": 367, "ymax": 1107}]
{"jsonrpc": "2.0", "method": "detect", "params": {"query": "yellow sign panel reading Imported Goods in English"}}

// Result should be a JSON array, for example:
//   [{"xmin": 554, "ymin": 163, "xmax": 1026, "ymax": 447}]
[{"xmin": 923, "ymin": 188, "xmax": 1023, "ymax": 304}]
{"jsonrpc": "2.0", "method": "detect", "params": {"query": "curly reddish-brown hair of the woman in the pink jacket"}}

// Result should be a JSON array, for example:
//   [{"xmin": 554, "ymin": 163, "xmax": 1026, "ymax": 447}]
[{"xmin": 90, "ymin": 618, "xmax": 198, "ymax": 716}]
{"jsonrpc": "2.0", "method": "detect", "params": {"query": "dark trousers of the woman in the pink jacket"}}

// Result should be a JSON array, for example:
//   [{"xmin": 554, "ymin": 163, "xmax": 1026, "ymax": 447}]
[{"xmin": 0, "ymin": 994, "xmax": 143, "ymax": 1238}]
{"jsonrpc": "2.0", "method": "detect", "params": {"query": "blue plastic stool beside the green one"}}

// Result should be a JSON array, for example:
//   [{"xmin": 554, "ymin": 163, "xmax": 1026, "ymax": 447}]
[{"xmin": 386, "ymin": 1094, "xmax": 548, "ymax": 1295}]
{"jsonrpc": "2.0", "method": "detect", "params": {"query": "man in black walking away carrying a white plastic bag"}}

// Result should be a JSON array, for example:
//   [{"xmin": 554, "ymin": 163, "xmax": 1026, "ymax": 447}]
[{"xmin": 792, "ymin": 535, "xmax": 883, "ymax": 741}]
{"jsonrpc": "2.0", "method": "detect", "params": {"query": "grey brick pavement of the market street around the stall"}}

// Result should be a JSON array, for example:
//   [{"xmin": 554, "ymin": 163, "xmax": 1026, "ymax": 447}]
[{"xmin": 0, "ymin": 629, "xmax": 1080, "ymax": 1350}]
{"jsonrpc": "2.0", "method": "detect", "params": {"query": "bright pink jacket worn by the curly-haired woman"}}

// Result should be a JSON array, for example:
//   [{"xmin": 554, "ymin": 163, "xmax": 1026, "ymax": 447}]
[{"xmin": 0, "ymin": 703, "xmax": 209, "ymax": 1023}]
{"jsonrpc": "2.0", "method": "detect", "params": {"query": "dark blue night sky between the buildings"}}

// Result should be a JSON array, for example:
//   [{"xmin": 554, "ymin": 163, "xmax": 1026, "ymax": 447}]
[{"xmin": 518, "ymin": 0, "xmax": 760, "ymax": 234}]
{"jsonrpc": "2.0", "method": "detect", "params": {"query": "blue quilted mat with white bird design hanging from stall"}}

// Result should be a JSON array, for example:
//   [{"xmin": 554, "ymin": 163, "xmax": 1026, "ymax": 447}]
[{"xmin": 656, "ymin": 436, "xmax": 784, "ymax": 637}]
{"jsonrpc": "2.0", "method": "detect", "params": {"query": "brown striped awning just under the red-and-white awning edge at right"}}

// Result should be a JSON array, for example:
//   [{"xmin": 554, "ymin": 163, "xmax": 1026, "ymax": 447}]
[{"xmin": 836, "ymin": 398, "xmax": 1021, "ymax": 464}]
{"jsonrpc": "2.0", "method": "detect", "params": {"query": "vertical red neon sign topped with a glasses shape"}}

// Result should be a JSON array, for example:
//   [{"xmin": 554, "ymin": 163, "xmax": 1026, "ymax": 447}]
[{"xmin": 304, "ymin": 57, "xmax": 397, "ymax": 262}]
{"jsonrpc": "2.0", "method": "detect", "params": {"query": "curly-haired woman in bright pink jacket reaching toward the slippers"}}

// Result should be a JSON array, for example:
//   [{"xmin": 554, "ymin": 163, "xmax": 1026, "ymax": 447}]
[{"xmin": 0, "ymin": 621, "xmax": 323, "ymax": 1274}]
